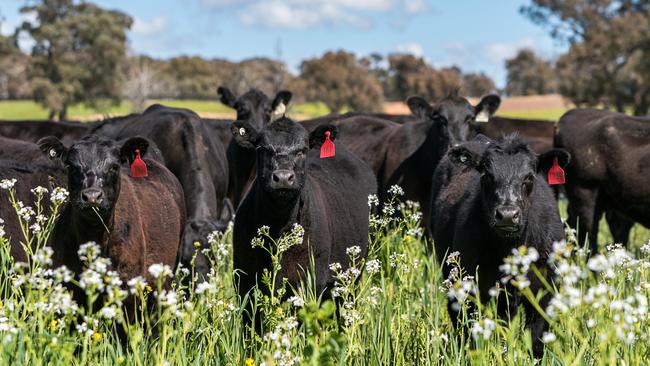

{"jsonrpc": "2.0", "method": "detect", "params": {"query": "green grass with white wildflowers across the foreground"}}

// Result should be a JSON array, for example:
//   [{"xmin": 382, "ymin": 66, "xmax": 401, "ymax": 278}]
[{"xmin": 0, "ymin": 181, "xmax": 650, "ymax": 366}]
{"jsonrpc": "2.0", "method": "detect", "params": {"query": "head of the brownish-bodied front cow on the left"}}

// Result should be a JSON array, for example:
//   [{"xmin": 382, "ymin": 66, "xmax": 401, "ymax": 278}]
[{"xmin": 38, "ymin": 135, "xmax": 149, "ymax": 218}]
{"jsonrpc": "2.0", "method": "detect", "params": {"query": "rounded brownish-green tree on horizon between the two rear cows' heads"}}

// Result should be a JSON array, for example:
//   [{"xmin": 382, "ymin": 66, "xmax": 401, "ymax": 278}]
[{"xmin": 300, "ymin": 51, "xmax": 384, "ymax": 112}]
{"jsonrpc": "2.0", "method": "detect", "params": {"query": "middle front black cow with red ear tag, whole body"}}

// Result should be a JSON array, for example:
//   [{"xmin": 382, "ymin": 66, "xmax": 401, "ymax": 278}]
[{"xmin": 233, "ymin": 118, "xmax": 376, "ymax": 304}]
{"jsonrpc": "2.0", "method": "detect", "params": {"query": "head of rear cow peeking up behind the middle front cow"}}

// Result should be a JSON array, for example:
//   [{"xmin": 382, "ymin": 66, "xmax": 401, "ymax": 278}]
[{"xmin": 217, "ymin": 86, "xmax": 291, "ymax": 137}]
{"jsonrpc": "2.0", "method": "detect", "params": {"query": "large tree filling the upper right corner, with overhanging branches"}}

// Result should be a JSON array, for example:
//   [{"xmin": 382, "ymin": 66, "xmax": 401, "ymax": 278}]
[{"xmin": 521, "ymin": 0, "xmax": 650, "ymax": 115}]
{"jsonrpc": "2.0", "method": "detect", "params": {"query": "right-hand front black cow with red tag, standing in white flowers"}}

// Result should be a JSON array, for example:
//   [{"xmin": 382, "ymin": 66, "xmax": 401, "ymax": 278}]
[{"xmin": 429, "ymin": 136, "xmax": 569, "ymax": 356}]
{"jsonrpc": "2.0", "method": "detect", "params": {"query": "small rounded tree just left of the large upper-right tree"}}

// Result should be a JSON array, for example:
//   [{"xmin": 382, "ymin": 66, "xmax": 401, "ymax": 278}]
[{"xmin": 505, "ymin": 49, "xmax": 557, "ymax": 95}]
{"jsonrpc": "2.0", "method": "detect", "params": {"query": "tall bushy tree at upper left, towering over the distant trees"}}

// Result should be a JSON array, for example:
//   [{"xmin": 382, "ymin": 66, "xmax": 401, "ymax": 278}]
[{"xmin": 20, "ymin": 0, "xmax": 132, "ymax": 120}]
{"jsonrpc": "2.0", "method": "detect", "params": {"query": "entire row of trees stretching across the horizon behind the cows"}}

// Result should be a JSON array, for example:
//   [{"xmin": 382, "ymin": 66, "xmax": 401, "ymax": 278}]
[{"xmin": 0, "ymin": 0, "xmax": 650, "ymax": 119}]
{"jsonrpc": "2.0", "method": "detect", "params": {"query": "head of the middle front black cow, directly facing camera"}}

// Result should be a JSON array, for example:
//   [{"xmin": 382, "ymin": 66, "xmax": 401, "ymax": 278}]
[{"xmin": 231, "ymin": 118, "xmax": 336, "ymax": 204}]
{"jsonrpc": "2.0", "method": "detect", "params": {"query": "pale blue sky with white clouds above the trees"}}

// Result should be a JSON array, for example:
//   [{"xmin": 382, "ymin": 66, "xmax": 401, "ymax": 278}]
[{"xmin": 0, "ymin": 0, "xmax": 564, "ymax": 87}]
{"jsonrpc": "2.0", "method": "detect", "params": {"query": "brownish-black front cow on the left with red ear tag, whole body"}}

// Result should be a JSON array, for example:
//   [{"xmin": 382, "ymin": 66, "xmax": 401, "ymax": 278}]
[{"xmin": 39, "ymin": 135, "xmax": 185, "ymax": 311}]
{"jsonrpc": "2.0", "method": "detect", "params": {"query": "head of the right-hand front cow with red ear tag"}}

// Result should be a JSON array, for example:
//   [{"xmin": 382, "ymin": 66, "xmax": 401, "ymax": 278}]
[{"xmin": 456, "ymin": 135, "xmax": 570, "ymax": 238}]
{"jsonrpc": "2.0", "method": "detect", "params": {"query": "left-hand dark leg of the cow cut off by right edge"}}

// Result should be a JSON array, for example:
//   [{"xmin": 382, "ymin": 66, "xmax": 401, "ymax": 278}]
[{"xmin": 567, "ymin": 186, "xmax": 600, "ymax": 253}]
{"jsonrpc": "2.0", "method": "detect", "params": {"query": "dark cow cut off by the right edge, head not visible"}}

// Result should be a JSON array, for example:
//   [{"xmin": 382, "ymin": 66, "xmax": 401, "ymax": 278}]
[{"xmin": 555, "ymin": 109, "xmax": 650, "ymax": 253}]
